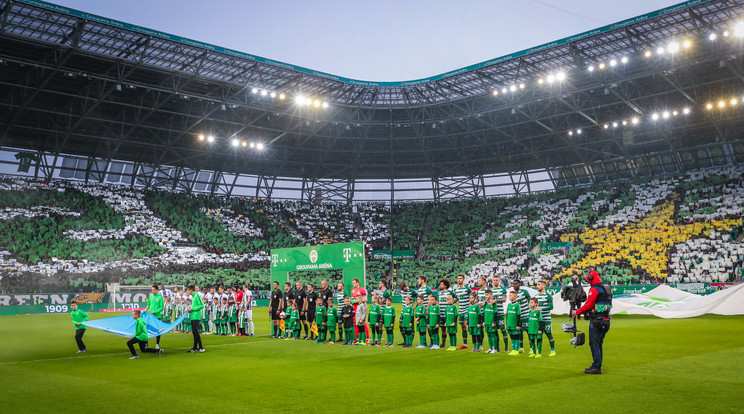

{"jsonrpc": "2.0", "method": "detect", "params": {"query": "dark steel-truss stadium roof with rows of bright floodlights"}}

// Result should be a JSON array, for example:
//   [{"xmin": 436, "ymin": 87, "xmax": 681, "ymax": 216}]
[{"xmin": 0, "ymin": 0, "xmax": 744, "ymax": 199}]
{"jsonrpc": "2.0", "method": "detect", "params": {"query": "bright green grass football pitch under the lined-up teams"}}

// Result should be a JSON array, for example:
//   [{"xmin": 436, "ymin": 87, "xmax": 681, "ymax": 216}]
[{"xmin": 0, "ymin": 308, "xmax": 744, "ymax": 413}]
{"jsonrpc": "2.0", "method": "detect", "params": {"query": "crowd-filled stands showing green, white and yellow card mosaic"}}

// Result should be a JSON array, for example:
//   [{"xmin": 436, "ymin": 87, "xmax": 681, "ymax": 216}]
[{"xmin": 0, "ymin": 166, "xmax": 744, "ymax": 287}]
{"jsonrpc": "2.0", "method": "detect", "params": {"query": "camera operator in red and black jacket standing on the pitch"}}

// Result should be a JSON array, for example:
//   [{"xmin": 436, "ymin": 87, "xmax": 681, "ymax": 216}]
[{"xmin": 574, "ymin": 270, "xmax": 612, "ymax": 374}]
